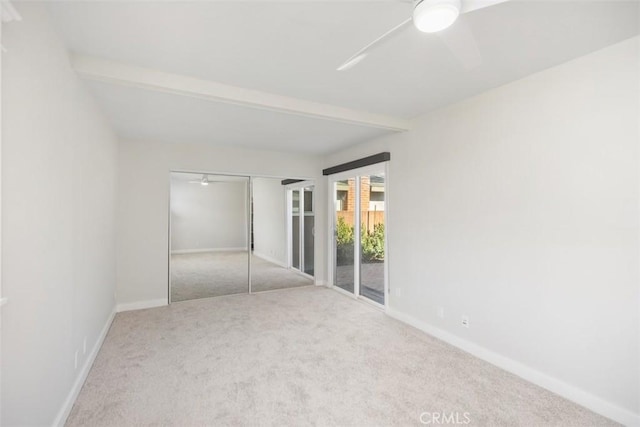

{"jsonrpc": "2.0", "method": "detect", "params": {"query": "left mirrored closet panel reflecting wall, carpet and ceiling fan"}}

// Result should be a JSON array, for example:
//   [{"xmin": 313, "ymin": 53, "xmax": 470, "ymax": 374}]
[{"xmin": 170, "ymin": 172, "xmax": 249, "ymax": 302}]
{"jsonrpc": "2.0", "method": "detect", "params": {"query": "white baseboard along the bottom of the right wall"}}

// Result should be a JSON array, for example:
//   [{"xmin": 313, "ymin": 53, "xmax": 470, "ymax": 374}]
[{"xmin": 386, "ymin": 308, "xmax": 640, "ymax": 426}]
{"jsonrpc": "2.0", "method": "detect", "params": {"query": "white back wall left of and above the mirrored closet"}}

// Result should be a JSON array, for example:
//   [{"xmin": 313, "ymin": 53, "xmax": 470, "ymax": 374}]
[{"xmin": 117, "ymin": 140, "xmax": 324, "ymax": 304}]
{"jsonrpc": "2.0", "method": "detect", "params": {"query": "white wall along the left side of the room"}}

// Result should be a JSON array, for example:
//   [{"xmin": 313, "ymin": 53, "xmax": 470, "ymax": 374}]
[{"xmin": 1, "ymin": 2, "xmax": 117, "ymax": 426}]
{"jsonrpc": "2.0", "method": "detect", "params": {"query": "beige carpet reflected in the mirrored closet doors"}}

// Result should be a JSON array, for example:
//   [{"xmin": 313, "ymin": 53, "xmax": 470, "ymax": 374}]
[{"xmin": 171, "ymin": 251, "xmax": 313, "ymax": 302}]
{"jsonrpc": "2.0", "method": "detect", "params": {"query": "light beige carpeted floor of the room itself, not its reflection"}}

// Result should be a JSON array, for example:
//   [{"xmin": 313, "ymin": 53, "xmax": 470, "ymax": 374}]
[{"xmin": 67, "ymin": 287, "xmax": 614, "ymax": 426}]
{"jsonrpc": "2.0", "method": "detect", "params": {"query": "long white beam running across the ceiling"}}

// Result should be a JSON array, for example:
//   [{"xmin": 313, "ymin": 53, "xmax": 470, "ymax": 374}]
[{"xmin": 71, "ymin": 55, "xmax": 410, "ymax": 132}]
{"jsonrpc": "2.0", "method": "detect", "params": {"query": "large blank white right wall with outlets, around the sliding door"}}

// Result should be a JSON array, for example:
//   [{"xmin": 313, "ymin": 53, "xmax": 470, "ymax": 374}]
[{"xmin": 325, "ymin": 38, "xmax": 640, "ymax": 424}]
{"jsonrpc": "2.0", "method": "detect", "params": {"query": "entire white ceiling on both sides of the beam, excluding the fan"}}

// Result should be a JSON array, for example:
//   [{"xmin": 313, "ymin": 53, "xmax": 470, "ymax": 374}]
[{"xmin": 49, "ymin": 0, "xmax": 640, "ymax": 153}]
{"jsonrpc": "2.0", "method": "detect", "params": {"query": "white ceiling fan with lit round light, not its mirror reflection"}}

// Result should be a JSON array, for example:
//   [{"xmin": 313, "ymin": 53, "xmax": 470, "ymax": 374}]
[{"xmin": 337, "ymin": 0, "xmax": 508, "ymax": 71}]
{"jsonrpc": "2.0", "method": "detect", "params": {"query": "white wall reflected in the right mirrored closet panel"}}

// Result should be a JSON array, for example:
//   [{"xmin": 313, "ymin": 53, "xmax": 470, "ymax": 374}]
[{"xmin": 253, "ymin": 178, "xmax": 287, "ymax": 266}]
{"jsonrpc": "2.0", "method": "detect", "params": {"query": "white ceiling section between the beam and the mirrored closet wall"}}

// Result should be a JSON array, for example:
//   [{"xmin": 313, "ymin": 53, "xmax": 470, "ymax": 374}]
[{"xmin": 86, "ymin": 82, "xmax": 388, "ymax": 154}]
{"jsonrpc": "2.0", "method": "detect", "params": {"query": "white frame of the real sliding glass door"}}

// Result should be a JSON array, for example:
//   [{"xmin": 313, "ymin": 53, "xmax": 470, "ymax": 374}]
[{"xmin": 327, "ymin": 162, "xmax": 390, "ymax": 311}]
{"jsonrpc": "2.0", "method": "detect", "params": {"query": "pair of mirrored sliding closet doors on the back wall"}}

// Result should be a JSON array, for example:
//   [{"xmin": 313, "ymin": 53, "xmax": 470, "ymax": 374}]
[{"xmin": 169, "ymin": 172, "xmax": 315, "ymax": 302}]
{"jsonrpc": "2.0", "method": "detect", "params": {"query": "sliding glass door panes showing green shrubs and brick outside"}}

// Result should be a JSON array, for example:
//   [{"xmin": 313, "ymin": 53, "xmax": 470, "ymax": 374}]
[{"xmin": 331, "ymin": 165, "xmax": 386, "ymax": 305}]
